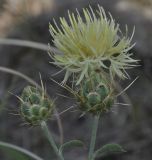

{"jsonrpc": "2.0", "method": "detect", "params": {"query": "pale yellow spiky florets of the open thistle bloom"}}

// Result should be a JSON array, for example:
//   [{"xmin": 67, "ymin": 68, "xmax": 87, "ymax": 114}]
[{"xmin": 50, "ymin": 6, "xmax": 136, "ymax": 84}]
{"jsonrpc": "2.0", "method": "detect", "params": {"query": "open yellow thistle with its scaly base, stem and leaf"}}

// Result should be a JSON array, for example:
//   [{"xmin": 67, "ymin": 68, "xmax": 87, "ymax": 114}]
[{"xmin": 49, "ymin": 5, "xmax": 137, "ymax": 160}]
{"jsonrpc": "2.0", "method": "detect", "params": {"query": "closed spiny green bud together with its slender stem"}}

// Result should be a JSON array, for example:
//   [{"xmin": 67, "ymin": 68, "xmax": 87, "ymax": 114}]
[{"xmin": 19, "ymin": 84, "xmax": 64, "ymax": 160}]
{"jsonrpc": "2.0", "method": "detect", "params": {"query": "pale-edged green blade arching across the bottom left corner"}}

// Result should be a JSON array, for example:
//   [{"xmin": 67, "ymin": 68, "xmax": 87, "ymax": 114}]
[{"xmin": 0, "ymin": 141, "xmax": 43, "ymax": 160}]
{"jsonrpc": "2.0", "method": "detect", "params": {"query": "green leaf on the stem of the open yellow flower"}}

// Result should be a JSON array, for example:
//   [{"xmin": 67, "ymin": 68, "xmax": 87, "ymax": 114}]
[{"xmin": 94, "ymin": 144, "xmax": 126, "ymax": 157}]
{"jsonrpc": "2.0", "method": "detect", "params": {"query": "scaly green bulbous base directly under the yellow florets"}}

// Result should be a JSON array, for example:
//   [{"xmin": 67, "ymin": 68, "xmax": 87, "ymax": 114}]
[{"xmin": 78, "ymin": 73, "xmax": 114, "ymax": 114}]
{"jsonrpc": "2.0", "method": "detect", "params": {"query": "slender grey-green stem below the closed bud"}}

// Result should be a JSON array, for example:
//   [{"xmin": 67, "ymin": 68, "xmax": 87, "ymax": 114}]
[{"xmin": 41, "ymin": 121, "xmax": 64, "ymax": 160}]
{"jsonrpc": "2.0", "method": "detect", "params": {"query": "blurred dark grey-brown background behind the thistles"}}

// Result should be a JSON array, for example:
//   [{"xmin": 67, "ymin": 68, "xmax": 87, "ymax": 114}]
[{"xmin": 0, "ymin": 0, "xmax": 152, "ymax": 160}]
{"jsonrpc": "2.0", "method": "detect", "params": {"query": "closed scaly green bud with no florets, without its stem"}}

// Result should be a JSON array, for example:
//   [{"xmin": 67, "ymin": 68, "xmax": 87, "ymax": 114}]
[{"xmin": 20, "ymin": 86, "xmax": 54, "ymax": 125}]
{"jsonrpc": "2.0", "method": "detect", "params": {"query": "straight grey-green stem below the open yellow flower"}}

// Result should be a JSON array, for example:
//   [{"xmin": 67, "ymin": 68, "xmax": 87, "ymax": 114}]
[{"xmin": 88, "ymin": 115, "xmax": 100, "ymax": 160}]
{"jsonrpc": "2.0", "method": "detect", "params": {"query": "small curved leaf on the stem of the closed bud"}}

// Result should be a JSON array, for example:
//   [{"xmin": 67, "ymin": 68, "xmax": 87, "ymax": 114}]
[{"xmin": 59, "ymin": 140, "xmax": 84, "ymax": 154}]
